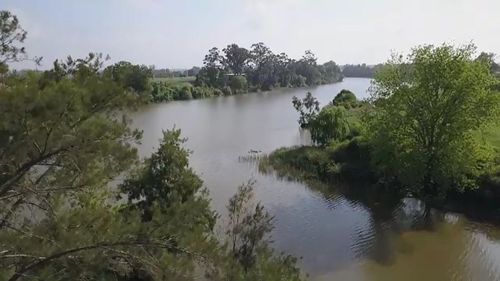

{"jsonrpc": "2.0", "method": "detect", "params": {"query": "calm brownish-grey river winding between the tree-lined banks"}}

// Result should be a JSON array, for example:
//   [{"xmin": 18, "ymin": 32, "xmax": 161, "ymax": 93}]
[{"xmin": 132, "ymin": 78, "xmax": 500, "ymax": 281}]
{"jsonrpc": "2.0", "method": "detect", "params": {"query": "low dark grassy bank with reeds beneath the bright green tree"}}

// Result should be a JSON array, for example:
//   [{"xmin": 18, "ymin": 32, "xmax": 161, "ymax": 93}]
[{"xmin": 259, "ymin": 138, "xmax": 500, "ymax": 225}]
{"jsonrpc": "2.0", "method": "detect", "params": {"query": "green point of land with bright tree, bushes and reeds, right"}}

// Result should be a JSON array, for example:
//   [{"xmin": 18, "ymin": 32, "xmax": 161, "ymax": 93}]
[{"xmin": 261, "ymin": 44, "xmax": 500, "ymax": 210}]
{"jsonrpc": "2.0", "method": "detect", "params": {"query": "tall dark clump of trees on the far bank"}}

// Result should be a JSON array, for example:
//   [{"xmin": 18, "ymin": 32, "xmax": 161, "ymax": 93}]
[{"xmin": 195, "ymin": 42, "xmax": 343, "ymax": 92}]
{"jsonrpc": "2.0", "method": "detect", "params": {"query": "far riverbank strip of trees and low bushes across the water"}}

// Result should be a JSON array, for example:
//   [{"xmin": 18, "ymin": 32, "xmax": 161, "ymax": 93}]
[{"xmin": 87, "ymin": 43, "xmax": 344, "ymax": 102}]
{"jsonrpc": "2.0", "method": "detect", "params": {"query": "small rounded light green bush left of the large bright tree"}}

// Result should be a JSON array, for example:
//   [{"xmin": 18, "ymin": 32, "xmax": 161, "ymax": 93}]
[{"xmin": 308, "ymin": 106, "xmax": 351, "ymax": 146}]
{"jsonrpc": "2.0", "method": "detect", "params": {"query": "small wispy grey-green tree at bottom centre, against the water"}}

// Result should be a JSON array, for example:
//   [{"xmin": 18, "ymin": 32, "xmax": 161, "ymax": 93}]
[{"xmin": 208, "ymin": 182, "xmax": 301, "ymax": 281}]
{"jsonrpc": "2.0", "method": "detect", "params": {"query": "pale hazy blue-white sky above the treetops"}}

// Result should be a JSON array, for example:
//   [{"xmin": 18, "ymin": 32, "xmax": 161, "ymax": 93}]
[{"xmin": 0, "ymin": 0, "xmax": 500, "ymax": 68}]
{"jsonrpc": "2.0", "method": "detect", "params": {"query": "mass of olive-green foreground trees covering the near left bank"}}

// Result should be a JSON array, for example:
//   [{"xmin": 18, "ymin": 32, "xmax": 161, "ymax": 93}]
[{"xmin": 0, "ymin": 11, "xmax": 302, "ymax": 281}]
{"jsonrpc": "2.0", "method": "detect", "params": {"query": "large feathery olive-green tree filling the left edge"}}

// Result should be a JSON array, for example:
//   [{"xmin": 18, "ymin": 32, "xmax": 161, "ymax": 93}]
[{"xmin": 0, "ymin": 56, "xmax": 148, "ymax": 280}]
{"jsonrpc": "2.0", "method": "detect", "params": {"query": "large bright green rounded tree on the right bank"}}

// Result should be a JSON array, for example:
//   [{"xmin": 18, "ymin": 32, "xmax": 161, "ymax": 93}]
[{"xmin": 370, "ymin": 44, "xmax": 498, "ymax": 196}]
